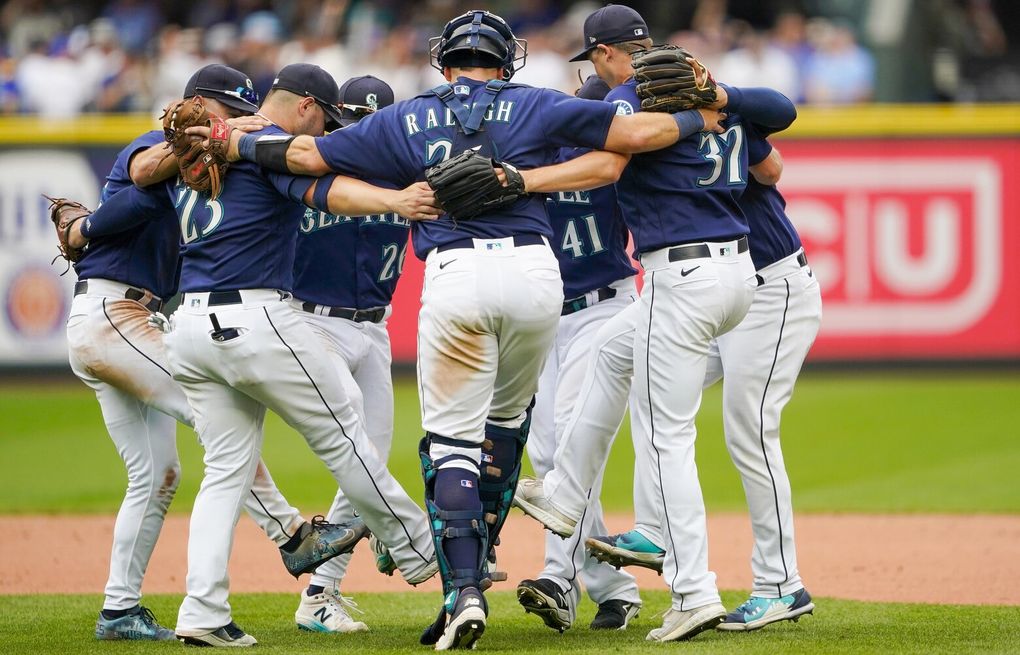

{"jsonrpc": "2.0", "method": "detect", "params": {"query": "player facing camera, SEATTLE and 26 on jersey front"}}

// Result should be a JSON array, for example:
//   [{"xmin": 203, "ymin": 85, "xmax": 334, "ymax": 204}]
[{"xmin": 292, "ymin": 75, "xmax": 411, "ymax": 633}]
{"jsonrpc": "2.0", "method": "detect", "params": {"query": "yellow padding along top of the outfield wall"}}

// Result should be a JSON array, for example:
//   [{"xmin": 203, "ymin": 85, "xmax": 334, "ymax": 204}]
[{"xmin": 0, "ymin": 103, "xmax": 1020, "ymax": 147}]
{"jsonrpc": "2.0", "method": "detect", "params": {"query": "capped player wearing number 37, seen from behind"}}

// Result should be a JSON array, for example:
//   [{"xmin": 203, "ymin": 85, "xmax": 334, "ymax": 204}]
[{"xmin": 516, "ymin": 5, "xmax": 796, "ymax": 642}]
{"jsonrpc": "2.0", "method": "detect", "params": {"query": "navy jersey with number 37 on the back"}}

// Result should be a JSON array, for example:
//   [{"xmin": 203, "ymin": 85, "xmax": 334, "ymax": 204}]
[{"xmin": 606, "ymin": 78, "xmax": 748, "ymax": 253}]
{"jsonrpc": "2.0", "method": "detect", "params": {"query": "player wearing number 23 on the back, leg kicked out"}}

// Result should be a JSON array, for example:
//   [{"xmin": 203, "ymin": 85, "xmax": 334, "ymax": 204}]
[{"xmin": 164, "ymin": 64, "xmax": 437, "ymax": 646}]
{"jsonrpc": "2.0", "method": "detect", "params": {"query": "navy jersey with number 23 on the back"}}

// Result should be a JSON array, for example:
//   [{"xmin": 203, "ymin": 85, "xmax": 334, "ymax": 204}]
[{"xmin": 173, "ymin": 125, "xmax": 315, "ymax": 292}]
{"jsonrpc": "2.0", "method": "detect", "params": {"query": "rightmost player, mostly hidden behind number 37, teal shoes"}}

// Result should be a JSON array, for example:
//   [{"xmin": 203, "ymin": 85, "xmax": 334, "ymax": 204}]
[{"xmin": 588, "ymin": 125, "xmax": 821, "ymax": 631}]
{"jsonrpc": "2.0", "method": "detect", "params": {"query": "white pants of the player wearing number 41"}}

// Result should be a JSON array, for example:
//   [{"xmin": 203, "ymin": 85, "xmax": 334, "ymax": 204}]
[{"xmin": 527, "ymin": 278, "xmax": 641, "ymax": 607}]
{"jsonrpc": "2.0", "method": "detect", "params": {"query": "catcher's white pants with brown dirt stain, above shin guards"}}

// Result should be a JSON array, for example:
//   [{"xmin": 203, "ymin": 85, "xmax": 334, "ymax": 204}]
[{"xmin": 418, "ymin": 238, "xmax": 563, "ymax": 461}]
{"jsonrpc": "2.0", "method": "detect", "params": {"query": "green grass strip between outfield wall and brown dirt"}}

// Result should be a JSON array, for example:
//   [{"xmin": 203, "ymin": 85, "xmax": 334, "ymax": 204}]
[{"xmin": 0, "ymin": 372, "xmax": 1020, "ymax": 513}]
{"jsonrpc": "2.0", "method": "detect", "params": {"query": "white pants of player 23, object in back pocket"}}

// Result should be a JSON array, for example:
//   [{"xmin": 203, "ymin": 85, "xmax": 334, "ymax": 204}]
[{"xmin": 164, "ymin": 290, "xmax": 435, "ymax": 635}]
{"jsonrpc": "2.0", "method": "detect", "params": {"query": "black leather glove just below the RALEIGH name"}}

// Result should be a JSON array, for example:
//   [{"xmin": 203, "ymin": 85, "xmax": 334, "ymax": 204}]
[{"xmin": 425, "ymin": 150, "xmax": 527, "ymax": 220}]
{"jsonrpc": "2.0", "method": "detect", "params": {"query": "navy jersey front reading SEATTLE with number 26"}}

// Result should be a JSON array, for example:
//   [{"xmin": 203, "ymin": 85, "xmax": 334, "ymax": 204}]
[{"xmin": 294, "ymin": 181, "xmax": 411, "ymax": 309}]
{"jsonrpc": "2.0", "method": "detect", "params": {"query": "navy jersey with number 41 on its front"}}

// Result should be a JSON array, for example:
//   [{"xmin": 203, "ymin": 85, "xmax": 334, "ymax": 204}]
[{"xmin": 546, "ymin": 148, "xmax": 638, "ymax": 298}]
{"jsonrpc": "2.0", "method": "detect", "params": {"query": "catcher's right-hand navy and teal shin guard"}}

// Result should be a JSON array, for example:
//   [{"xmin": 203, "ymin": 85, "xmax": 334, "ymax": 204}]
[{"xmin": 478, "ymin": 400, "xmax": 534, "ymax": 581}]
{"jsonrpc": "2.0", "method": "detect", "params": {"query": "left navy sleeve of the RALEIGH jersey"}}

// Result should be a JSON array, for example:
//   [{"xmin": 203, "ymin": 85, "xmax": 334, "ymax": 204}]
[{"xmin": 315, "ymin": 111, "xmax": 410, "ymax": 179}]
